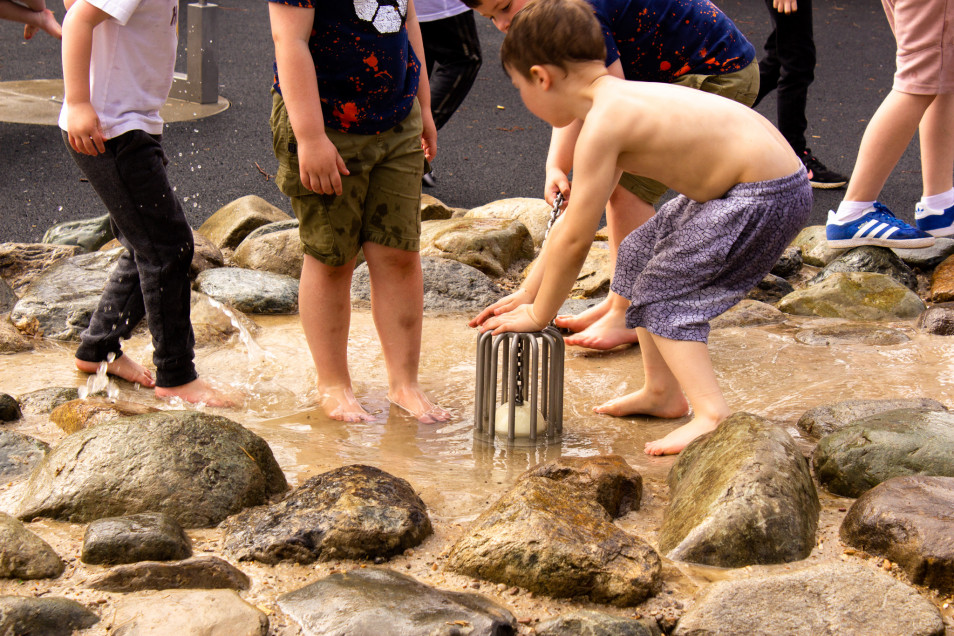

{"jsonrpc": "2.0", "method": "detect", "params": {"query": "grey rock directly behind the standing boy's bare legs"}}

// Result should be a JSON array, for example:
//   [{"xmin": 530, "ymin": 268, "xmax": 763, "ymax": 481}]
[{"xmin": 351, "ymin": 257, "xmax": 504, "ymax": 314}]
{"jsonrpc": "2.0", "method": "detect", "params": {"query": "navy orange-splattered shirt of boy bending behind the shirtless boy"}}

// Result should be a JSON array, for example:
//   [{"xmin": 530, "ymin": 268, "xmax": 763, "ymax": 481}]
[{"xmin": 587, "ymin": 0, "xmax": 755, "ymax": 84}]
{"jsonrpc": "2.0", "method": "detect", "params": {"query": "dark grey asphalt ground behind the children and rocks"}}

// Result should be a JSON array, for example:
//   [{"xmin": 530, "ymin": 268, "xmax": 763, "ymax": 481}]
[{"xmin": 0, "ymin": 0, "xmax": 921, "ymax": 242}]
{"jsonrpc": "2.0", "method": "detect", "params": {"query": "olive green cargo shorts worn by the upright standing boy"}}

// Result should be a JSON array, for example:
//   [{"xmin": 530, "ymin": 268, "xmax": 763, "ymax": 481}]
[{"xmin": 270, "ymin": 89, "xmax": 425, "ymax": 267}]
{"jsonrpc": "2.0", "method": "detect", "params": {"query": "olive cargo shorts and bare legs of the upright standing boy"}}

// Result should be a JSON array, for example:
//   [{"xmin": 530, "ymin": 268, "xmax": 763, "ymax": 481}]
[{"xmin": 271, "ymin": 93, "xmax": 450, "ymax": 423}]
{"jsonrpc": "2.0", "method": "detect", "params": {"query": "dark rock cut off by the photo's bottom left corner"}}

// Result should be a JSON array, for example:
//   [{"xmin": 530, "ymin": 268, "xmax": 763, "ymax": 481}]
[{"xmin": 0, "ymin": 596, "xmax": 99, "ymax": 636}]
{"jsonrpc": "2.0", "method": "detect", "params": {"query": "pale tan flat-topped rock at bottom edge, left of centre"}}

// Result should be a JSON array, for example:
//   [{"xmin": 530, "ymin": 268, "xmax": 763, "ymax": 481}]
[{"xmin": 110, "ymin": 590, "xmax": 268, "ymax": 636}]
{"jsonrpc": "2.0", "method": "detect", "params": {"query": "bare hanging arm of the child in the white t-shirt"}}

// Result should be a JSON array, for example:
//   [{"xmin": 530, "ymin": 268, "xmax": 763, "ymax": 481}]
[{"xmin": 62, "ymin": 0, "xmax": 109, "ymax": 155}]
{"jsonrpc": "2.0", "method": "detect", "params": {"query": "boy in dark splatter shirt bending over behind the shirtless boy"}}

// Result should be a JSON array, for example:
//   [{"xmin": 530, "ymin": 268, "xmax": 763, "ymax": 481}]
[{"xmin": 463, "ymin": 0, "xmax": 759, "ymax": 349}]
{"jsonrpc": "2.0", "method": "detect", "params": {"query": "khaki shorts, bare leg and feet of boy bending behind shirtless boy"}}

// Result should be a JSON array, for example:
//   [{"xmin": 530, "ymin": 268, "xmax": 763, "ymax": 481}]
[{"xmin": 555, "ymin": 61, "xmax": 759, "ymax": 349}]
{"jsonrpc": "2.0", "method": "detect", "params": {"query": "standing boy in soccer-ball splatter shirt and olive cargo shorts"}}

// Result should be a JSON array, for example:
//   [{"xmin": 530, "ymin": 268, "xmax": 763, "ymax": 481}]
[{"xmin": 269, "ymin": 0, "xmax": 450, "ymax": 423}]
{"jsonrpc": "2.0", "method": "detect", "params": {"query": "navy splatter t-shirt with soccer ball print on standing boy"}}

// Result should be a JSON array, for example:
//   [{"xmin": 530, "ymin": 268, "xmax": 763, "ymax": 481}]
[{"xmin": 268, "ymin": 0, "xmax": 421, "ymax": 135}]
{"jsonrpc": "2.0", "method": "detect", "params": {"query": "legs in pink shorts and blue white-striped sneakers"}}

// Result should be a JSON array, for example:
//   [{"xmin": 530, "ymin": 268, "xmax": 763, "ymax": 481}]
[{"xmin": 826, "ymin": 0, "xmax": 954, "ymax": 247}]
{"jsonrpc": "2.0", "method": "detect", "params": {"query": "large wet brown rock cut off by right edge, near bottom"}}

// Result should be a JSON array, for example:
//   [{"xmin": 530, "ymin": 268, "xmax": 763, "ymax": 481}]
[{"xmin": 839, "ymin": 476, "xmax": 954, "ymax": 595}]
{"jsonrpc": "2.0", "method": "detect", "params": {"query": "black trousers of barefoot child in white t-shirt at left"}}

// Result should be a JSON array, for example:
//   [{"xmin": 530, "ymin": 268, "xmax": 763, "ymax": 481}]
[{"xmin": 63, "ymin": 130, "xmax": 198, "ymax": 387}]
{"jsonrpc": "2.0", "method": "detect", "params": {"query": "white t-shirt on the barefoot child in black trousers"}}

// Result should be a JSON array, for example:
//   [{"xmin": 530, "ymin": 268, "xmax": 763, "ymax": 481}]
[{"xmin": 59, "ymin": 0, "xmax": 179, "ymax": 139}]
